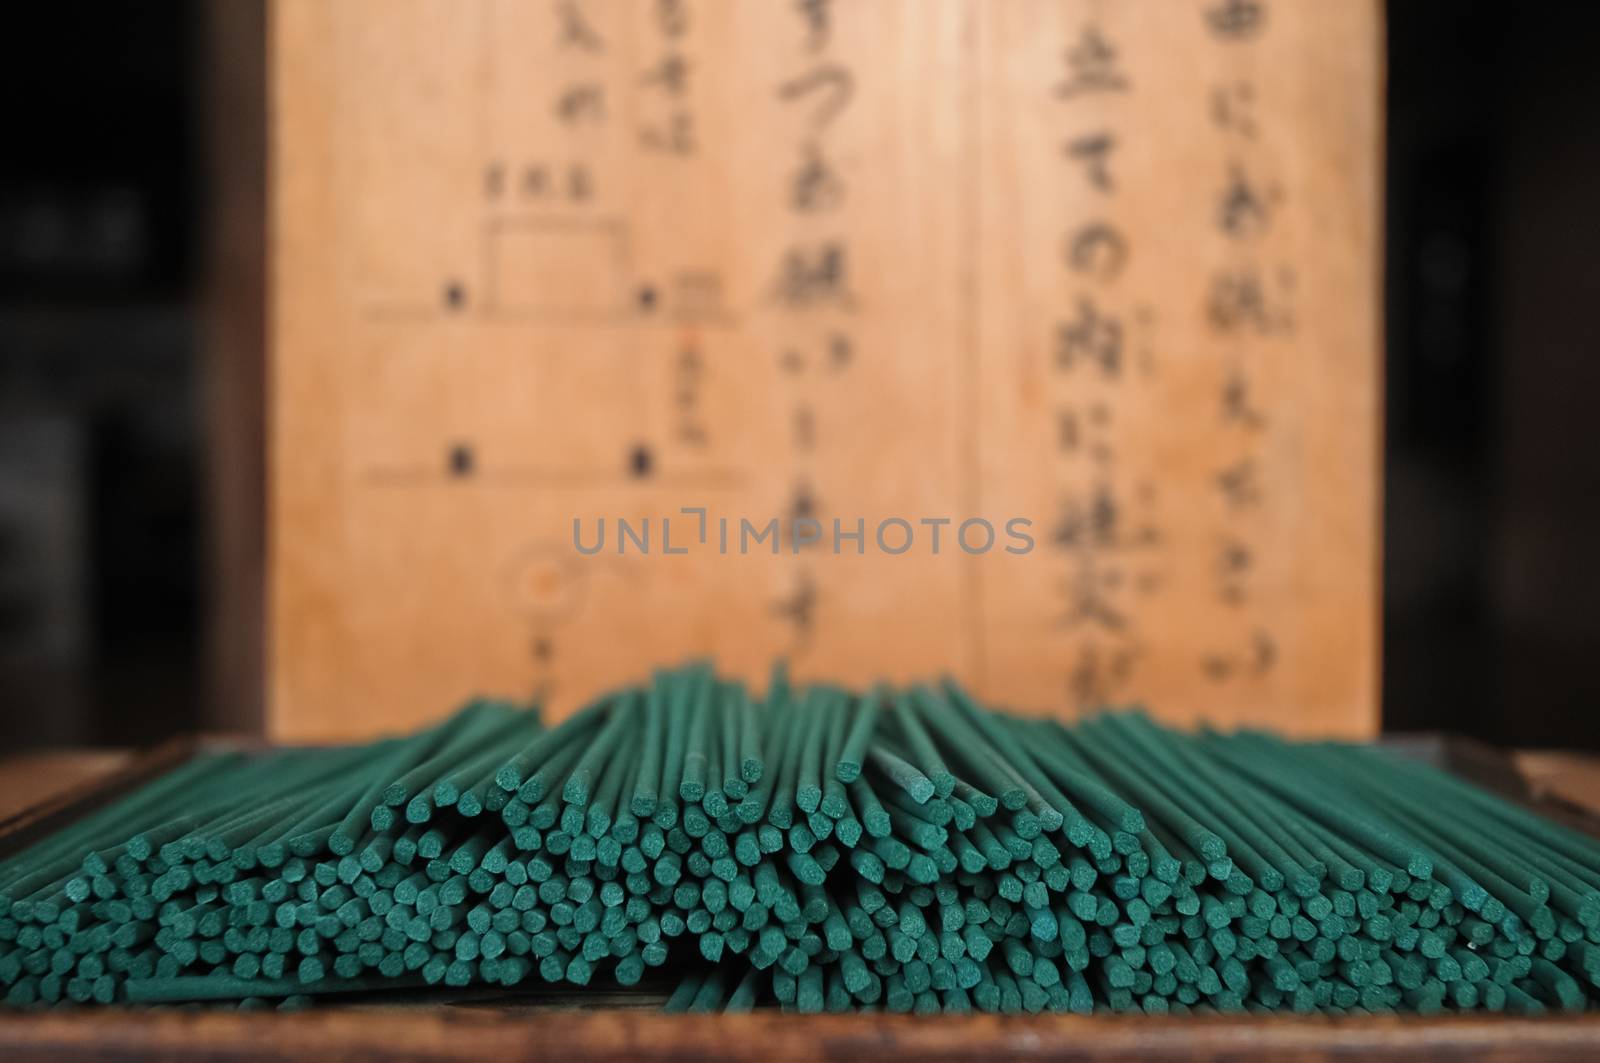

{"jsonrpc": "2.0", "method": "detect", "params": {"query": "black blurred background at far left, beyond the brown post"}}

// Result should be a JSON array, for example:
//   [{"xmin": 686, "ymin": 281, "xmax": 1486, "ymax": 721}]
[{"xmin": 0, "ymin": 2, "xmax": 205, "ymax": 749}]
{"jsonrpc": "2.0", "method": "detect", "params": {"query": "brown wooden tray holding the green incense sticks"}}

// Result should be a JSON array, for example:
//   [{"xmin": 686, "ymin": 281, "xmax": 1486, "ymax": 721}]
[{"xmin": 0, "ymin": 735, "xmax": 1600, "ymax": 1063}]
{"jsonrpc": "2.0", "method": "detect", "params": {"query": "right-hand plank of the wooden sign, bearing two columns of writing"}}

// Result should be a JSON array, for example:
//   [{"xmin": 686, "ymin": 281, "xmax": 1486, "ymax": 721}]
[{"xmin": 981, "ymin": 0, "xmax": 1379, "ymax": 733}]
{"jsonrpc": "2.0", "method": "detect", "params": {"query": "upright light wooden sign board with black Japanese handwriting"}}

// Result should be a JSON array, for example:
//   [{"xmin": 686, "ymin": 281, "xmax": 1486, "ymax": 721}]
[{"xmin": 267, "ymin": 0, "xmax": 1381, "ymax": 738}]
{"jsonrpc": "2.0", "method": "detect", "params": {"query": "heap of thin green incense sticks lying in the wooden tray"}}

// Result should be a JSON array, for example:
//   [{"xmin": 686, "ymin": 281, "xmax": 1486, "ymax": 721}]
[{"xmin": 0, "ymin": 663, "xmax": 1600, "ymax": 1013}]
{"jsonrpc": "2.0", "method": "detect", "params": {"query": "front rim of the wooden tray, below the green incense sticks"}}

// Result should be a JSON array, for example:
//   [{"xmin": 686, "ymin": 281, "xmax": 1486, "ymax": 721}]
[{"xmin": 0, "ymin": 1007, "xmax": 1600, "ymax": 1063}]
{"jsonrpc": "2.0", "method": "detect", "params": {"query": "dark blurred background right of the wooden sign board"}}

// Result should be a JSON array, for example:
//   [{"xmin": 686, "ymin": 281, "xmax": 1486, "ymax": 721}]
[{"xmin": 1384, "ymin": 0, "xmax": 1600, "ymax": 748}]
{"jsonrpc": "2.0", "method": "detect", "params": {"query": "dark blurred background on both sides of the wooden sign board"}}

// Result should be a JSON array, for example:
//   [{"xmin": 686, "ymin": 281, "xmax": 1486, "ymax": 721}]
[{"xmin": 0, "ymin": 0, "xmax": 1600, "ymax": 749}]
